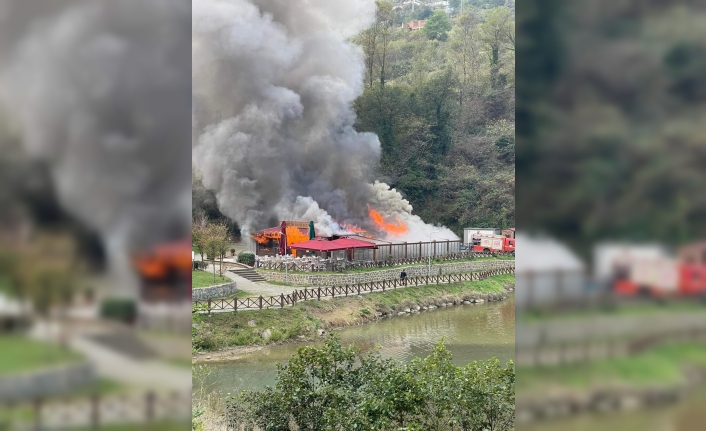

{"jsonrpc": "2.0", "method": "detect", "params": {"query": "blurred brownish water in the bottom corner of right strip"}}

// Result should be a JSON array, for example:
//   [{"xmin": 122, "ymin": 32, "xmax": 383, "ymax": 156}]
[{"xmin": 517, "ymin": 386, "xmax": 706, "ymax": 431}]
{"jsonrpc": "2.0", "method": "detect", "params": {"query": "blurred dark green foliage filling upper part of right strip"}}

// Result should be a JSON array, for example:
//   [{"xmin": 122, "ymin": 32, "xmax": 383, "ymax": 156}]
[{"xmin": 517, "ymin": 0, "xmax": 706, "ymax": 256}]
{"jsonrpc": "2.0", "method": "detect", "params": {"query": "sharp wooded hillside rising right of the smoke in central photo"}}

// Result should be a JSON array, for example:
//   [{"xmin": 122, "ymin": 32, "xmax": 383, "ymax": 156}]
[{"xmin": 354, "ymin": 1, "xmax": 515, "ymax": 234}]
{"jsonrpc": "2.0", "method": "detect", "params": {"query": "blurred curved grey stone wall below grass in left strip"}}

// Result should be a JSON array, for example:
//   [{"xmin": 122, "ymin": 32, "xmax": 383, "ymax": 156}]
[{"xmin": 0, "ymin": 362, "xmax": 96, "ymax": 402}]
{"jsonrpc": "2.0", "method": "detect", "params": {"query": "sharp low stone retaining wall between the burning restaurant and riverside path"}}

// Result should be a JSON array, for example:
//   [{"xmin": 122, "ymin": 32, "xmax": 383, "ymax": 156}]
[{"xmin": 256, "ymin": 260, "xmax": 515, "ymax": 286}]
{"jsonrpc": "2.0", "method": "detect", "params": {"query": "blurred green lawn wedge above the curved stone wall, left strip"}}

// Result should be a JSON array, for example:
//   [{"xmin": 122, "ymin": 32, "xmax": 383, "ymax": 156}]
[{"xmin": 0, "ymin": 335, "xmax": 82, "ymax": 374}]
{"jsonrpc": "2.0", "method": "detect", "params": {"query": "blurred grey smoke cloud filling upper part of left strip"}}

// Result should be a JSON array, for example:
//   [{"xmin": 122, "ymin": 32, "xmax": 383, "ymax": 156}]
[{"xmin": 0, "ymin": 0, "xmax": 191, "ymax": 294}]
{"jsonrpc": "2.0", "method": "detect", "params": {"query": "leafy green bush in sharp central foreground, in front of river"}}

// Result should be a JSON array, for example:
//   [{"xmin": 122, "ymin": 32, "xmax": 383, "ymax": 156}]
[{"xmin": 228, "ymin": 336, "xmax": 515, "ymax": 431}]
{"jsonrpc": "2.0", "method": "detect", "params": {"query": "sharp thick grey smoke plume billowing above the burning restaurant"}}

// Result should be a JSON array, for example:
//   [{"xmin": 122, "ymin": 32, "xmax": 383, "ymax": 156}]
[{"xmin": 192, "ymin": 0, "xmax": 456, "ymax": 241}]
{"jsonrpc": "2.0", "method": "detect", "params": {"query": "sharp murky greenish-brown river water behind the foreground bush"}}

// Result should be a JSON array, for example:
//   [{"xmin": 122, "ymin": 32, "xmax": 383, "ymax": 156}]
[{"xmin": 194, "ymin": 296, "xmax": 515, "ymax": 395}]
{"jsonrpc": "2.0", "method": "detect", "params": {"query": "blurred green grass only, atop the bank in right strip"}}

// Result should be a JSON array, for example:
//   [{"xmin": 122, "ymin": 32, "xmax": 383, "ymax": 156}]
[{"xmin": 517, "ymin": 342, "xmax": 706, "ymax": 394}]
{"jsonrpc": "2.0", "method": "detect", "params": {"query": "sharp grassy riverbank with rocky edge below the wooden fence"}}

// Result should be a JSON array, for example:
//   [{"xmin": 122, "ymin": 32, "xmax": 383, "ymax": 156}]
[{"xmin": 192, "ymin": 274, "xmax": 515, "ymax": 362}]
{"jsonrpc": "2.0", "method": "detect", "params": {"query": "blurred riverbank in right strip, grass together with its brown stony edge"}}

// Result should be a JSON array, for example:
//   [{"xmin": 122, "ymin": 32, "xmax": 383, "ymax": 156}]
[{"xmin": 517, "ymin": 341, "xmax": 706, "ymax": 423}]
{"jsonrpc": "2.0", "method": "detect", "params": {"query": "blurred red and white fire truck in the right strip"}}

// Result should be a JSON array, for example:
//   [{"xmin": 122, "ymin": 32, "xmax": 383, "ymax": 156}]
[{"xmin": 603, "ymin": 244, "xmax": 706, "ymax": 300}]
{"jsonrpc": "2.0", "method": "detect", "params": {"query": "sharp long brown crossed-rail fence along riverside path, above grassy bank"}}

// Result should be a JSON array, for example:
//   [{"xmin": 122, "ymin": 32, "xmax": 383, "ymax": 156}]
[{"xmin": 192, "ymin": 266, "xmax": 515, "ymax": 314}]
